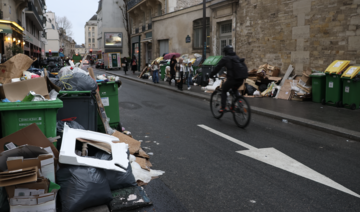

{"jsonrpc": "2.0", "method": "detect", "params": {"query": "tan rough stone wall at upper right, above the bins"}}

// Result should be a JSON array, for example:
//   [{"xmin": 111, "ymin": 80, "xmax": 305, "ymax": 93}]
[{"xmin": 236, "ymin": 0, "xmax": 360, "ymax": 74}]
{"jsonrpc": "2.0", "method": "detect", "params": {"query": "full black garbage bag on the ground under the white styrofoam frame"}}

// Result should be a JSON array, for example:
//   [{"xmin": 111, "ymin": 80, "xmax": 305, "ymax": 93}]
[{"xmin": 56, "ymin": 164, "xmax": 112, "ymax": 212}]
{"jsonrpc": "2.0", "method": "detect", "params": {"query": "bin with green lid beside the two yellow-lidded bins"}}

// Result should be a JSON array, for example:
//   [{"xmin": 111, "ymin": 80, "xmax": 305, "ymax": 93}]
[{"xmin": 310, "ymin": 73, "xmax": 326, "ymax": 103}]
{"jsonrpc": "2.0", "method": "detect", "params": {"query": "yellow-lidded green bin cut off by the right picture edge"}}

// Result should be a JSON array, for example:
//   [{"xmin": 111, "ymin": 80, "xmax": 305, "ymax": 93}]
[{"xmin": 341, "ymin": 66, "xmax": 360, "ymax": 110}]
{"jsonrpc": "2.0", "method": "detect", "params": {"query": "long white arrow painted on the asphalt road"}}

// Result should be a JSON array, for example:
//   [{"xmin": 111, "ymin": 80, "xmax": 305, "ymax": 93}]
[{"xmin": 198, "ymin": 125, "xmax": 360, "ymax": 198}]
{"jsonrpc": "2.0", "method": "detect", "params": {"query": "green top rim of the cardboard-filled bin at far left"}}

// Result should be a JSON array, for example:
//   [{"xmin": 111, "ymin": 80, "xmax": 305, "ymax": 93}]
[{"xmin": 0, "ymin": 99, "xmax": 64, "ymax": 111}]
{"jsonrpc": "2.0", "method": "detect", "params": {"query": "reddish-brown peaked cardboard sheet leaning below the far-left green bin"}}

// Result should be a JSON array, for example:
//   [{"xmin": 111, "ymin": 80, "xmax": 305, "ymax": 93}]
[{"xmin": 0, "ymin": 124, "xmax": 59, "ymax": 159}]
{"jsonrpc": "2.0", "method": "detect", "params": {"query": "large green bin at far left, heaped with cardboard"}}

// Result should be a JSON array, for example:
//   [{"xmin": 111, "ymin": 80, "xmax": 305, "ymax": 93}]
[{"xmin": 0, "ymin": 99, "xmax": 63, "ymax": 142}]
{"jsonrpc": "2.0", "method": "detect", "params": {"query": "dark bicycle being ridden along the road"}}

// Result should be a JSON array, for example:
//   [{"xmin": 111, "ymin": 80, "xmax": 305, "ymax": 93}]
[{"xmin": 210, "ymin": 77, "xmax": 251, "ymax": 128}]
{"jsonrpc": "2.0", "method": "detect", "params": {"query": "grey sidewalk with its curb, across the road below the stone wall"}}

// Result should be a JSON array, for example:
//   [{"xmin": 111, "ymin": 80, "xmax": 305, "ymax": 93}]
[{"xmin": 106, "ymin": 70, "xmax": 360, "ymax": 141}]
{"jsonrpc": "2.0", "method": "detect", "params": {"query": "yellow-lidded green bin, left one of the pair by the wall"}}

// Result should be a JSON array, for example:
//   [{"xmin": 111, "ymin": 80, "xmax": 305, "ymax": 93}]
[{"xmin": 322, "ymin": 60, "xmax": 350, "ymax": 107}]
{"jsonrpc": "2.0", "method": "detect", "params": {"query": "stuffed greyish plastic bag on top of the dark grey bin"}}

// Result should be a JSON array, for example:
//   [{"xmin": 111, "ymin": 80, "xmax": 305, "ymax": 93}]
[{"xmin": 60, "ymin": 72, "xmax": 97, "ymax": 91}]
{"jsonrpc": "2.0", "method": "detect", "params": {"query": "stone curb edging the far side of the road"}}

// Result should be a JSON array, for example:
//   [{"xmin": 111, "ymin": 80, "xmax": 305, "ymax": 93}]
[{"xmin": 105, "ymin": 71, "xmax": 360, "ymax": 141}]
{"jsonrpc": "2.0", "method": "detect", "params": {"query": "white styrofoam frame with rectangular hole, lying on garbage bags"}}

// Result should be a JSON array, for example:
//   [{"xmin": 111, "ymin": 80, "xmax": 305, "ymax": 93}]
[{"xmin": 59, "ymin": 123, "xmax": 129, "ymax": 172}]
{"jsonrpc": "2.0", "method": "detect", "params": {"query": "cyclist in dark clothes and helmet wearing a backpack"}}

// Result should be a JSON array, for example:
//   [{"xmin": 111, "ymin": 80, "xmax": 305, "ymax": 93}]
[{"xmin": 210, "ymin": 45, "xmax": 248, "ymax": 113}]
